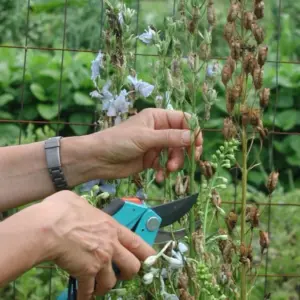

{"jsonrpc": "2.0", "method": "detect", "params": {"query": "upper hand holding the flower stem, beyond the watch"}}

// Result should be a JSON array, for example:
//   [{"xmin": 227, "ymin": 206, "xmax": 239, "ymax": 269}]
[{"xmin": 95, "ymin": 109, "xmax": 203, "ymax": 181}]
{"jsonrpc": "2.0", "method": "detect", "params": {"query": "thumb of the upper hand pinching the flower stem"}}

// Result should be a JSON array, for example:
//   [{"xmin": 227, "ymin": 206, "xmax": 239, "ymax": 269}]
[{"xmin": 145, "ymin": 129, "xmax": 193, "ymax": 149}]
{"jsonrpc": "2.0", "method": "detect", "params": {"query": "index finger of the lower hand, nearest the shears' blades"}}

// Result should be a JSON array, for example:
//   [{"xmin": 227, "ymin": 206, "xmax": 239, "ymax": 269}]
[{"xmin": 118, "ymin": 225, "xmax": 156, "ymax": 261}]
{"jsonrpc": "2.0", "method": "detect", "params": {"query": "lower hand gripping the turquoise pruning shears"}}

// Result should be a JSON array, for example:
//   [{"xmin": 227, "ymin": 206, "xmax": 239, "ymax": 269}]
[{"xmin": 41, "ymin": 191, "xmax": 155, "ymax": 300}]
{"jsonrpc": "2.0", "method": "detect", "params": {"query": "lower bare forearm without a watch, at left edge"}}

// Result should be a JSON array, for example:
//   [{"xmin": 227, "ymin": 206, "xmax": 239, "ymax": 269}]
[{"xmin": 0, "ymin": 204, "xmax": 53, "ymax": 287}]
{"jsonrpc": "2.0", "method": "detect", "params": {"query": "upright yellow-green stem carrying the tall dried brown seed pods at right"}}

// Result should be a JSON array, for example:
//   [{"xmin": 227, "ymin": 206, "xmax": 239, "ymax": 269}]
[{"xmin": 241, "ymin": 125, "xmax": 248, "ymax": 300}]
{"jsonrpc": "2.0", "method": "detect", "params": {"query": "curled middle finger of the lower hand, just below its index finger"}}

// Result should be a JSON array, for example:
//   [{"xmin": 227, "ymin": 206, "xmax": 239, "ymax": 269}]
[{"xmin": 113, "ymin": 245, "xmax": 141, "ymax": 280}]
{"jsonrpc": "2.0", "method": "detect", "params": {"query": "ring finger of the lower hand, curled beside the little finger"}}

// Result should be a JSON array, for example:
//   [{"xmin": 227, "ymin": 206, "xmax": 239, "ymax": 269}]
[{"xmin": 94, "ymin": 263, "xmax": 117, "ymax": 296}]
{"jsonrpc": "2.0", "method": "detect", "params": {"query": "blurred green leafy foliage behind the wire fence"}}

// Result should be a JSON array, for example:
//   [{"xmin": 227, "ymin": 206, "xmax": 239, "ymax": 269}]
[{"xmin": 0, "ymin": 0, "xmax": 300, "ymax": 299}]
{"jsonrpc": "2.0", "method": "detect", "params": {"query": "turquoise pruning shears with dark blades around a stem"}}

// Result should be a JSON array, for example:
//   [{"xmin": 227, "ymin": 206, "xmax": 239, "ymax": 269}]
[{"xmin": 57, "ymin": 194, "xmax": 200, "ymax": 300}]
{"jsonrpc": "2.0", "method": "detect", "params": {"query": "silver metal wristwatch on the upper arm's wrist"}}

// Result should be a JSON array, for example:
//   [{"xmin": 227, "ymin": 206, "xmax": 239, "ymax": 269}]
[{"xmin": 44, "ymin": 136, "xmax": 69, "ymax": 191}]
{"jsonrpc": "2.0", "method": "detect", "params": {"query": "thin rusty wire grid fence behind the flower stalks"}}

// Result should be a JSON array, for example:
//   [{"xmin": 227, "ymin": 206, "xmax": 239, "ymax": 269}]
[{"xmin": 0, "ymin": 0, "xmax": 300, "ymax": 300}]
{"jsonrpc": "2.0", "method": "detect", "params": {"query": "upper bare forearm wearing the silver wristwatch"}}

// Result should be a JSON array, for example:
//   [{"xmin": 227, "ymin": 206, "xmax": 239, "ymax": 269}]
[{"xmin": 0, "ymin": 135, "xmax": 101, "ymax": 211}]
